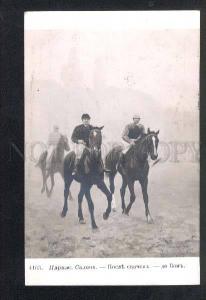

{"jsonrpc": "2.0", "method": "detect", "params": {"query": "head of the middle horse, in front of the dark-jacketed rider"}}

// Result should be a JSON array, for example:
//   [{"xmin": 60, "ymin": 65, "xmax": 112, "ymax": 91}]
[{"xmin": 89, "ymin": 126, "xmax": 104, "ymax": 159}]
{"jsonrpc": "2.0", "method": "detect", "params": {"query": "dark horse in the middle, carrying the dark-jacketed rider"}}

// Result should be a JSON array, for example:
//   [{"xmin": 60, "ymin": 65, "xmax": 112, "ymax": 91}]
[{"xmin": 61, "ymin": 126, "xmax": 112, "ymax": 229}]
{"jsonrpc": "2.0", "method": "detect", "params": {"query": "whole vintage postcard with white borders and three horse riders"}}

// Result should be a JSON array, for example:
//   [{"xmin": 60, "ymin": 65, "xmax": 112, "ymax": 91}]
[{"xmin": 24, "ymin": 11, "xmax": 200, "ymax": 286}]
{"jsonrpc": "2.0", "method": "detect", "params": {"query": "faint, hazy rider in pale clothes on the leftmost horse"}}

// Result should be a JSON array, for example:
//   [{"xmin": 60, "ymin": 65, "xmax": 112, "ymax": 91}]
[{"xmin": 46, "ymin": 125, "xmax": 61, "ymax": 169}]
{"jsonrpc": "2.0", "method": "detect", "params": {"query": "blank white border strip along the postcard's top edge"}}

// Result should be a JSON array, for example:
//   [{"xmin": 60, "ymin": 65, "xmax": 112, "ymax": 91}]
[{"xmin": 24, "ymin": 11, "xmax": 200, "ymax": 31}]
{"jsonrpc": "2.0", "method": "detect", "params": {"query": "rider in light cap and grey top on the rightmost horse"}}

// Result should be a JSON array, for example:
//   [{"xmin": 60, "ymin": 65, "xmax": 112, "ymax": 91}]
[{"xmin": 120, "ymin": 114, "xmax": 145, "ymax": 163}]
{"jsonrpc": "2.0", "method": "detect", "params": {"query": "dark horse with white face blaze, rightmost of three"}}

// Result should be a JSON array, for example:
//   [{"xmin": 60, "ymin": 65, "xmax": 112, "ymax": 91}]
[{"xmin": 105, "ymin": 128, "xmax": 159, "ymax": 223}]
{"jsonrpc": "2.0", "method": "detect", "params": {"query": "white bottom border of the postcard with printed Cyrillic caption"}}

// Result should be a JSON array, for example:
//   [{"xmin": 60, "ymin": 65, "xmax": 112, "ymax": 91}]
[{"xmin": 25, "ymin": 257, "xmax": 200, "ymax": 286}]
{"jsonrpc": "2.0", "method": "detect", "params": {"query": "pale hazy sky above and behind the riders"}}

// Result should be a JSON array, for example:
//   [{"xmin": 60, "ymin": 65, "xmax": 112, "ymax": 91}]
[{"xmin": 25, "ymin": 13, "xmax": 199, "ymax": 145}]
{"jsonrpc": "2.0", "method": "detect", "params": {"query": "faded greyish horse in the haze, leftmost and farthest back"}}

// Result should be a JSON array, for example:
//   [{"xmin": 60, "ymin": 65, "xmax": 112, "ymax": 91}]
[{"xmin": 36, "ymin": 135, "xmax": 72, "ymax": 200}]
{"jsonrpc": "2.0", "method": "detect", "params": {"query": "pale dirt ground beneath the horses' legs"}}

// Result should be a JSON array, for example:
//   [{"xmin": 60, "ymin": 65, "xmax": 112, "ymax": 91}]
[{"xmin": 25, "ymin": 162, "xmax": 199, "ymax": 258}]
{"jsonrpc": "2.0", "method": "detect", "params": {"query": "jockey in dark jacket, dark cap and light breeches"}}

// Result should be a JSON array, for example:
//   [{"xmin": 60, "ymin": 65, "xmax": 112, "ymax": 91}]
[{"xmin": 71, "ymin": 114, "xmax": 93, "ymax": 175}]
